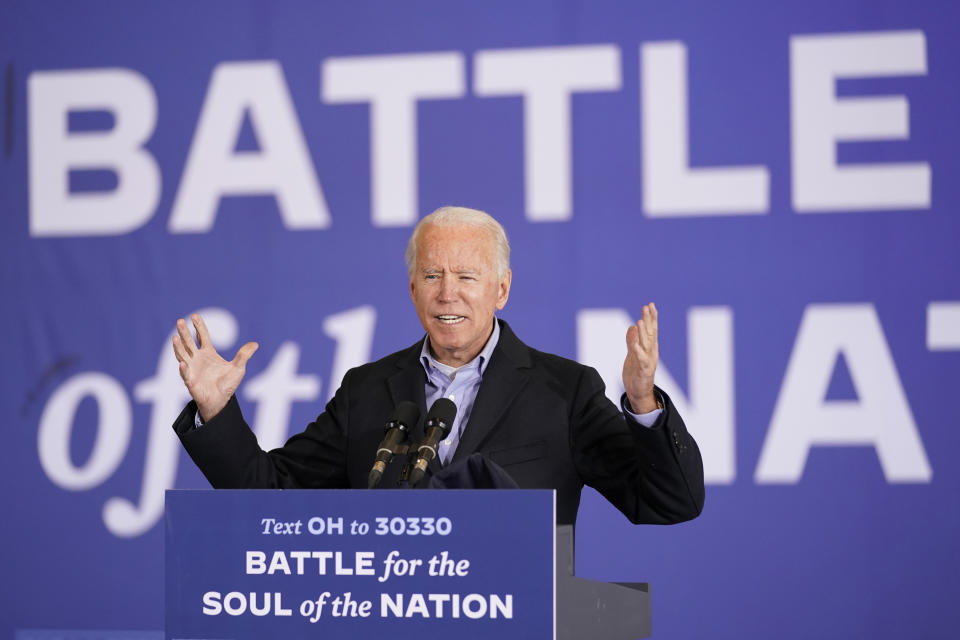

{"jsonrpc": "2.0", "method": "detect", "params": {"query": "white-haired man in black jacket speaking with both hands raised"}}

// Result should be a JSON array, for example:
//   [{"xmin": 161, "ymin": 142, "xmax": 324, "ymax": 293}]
[{"xmin": 173, "ymin": 207, "xmax": 704, "ymax": 524}]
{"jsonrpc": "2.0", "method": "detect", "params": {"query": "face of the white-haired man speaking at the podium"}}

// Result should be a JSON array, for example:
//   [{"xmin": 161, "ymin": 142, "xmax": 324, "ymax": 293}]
[{"xmin": 410, "ymin": 225, "xmax": 511, "ymax": 367}]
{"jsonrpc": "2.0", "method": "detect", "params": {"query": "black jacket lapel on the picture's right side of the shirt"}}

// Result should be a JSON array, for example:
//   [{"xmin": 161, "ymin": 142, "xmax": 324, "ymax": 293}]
[{"xmin": 452, "ymin": 320, "xmax": 531, "ymax": 462}]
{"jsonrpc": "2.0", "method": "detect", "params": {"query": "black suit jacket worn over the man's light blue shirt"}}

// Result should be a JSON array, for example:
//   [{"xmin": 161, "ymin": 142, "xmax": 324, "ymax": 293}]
[{"xmin": 174, "ymin": 320, "xmax": 704, "ymax": 524}]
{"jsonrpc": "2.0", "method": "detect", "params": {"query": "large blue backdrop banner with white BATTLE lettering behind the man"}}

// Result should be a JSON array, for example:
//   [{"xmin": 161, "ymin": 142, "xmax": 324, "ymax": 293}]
[{"xmin": 0, "ymin": 0, "xmax": 960, "ymax": 639}]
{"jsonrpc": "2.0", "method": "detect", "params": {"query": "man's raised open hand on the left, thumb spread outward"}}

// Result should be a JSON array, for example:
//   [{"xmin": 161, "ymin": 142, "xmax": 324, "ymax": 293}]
[{"xmin": 173, "ymin": 313, "xmax": 260, "ymax": 421}]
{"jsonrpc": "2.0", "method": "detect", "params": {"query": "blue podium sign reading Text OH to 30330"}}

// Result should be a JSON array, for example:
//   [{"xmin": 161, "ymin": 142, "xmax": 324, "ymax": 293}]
[{"xmin": 166, "ymin": 490, "xmax": 555, "ymax": 640}]
